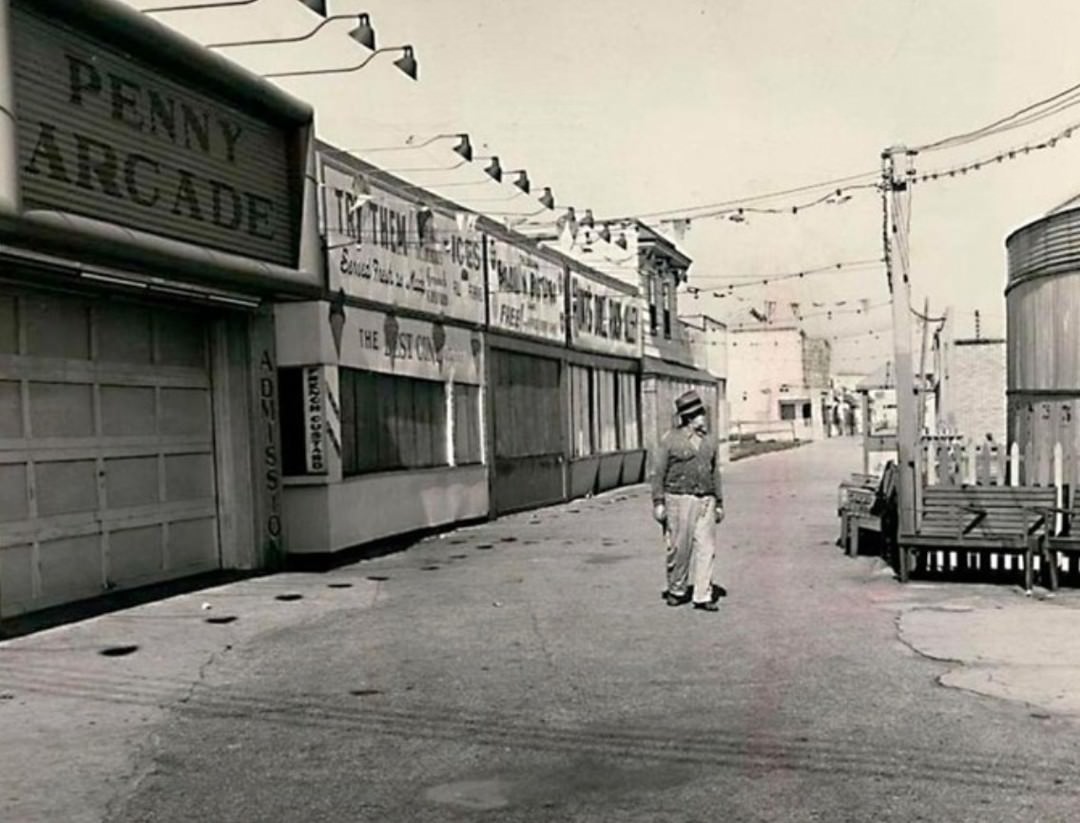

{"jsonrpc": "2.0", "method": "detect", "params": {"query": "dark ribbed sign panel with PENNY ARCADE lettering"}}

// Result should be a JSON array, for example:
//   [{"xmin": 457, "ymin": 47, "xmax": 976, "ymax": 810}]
[{"xmin": 11, "ymin": 4, "xmax": 299, "ymax": 267}]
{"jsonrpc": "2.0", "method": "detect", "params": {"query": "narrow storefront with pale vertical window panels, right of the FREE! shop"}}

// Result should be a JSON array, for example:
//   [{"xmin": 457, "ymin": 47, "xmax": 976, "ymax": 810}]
[{"xmin": 567, "ymin": 267, "xmax": 645, "ymax": 497}]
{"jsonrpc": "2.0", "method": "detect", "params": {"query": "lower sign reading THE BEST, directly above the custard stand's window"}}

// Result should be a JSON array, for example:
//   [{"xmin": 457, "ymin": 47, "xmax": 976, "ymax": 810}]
[{"xmin": 340, "ymin": 306, "xmax": 484, "ymax": 386}]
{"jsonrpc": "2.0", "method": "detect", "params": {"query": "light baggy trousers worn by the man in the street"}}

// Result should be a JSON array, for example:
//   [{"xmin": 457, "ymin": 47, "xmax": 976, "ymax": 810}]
[{"xmin": 664, "ymin": 495, "xmax": 716, "ymax": 603}]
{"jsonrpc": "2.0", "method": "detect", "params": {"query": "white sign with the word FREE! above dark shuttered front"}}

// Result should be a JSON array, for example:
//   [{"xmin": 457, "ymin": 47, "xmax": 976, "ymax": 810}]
[{"xmin": 485, "ymin": 238, "xmax": 566, "ymax": 342}]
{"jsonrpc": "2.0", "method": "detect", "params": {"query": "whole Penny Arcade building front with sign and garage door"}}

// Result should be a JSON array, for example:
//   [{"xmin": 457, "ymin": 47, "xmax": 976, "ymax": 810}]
[{"xmin": 0, "ymin": 0, "xmax": 320, "ymax": 617}]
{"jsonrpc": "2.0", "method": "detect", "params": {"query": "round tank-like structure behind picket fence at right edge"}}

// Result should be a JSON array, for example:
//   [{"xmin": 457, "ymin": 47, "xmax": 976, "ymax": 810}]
[{"xmin": 1005, "ymin": 208, "xmax": 1080, "ymax": 489}]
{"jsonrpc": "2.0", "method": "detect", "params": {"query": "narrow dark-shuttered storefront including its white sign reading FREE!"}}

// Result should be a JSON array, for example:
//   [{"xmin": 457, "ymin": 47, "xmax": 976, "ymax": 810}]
[{"xmin": 484, "ymin": 227, "xmax": 569, "ymax": 515}]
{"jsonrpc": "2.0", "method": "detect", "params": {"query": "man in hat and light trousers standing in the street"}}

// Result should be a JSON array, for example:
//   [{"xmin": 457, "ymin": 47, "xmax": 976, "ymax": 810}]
[{"xmin": 652, "ymin": 391, "xmax": 724, "ymax": 611}]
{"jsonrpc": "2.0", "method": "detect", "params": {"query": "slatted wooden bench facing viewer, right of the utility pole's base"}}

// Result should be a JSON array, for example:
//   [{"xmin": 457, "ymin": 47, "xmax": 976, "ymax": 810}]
[{"xmin": 897, "ymin": 486, "xmax": 1055, "ymax": 591}]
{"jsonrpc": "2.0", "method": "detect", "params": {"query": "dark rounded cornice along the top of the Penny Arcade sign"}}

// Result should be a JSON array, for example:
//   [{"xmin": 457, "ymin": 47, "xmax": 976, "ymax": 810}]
[{"xmin": 29, "ymin": 0, "xmax": 314, "ymax": 124}]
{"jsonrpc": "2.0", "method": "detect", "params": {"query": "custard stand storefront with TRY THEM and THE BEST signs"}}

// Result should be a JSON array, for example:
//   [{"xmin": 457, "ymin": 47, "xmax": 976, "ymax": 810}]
[{"xmin": 275, "ymin": 146, "xmax": 489, "ymax": 554}]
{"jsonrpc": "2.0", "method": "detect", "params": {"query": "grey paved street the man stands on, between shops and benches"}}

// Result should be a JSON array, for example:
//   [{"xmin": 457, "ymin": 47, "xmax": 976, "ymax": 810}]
[{"xmin": 6, "ymin": 440, "xmax": 1080, "ymax": 823}]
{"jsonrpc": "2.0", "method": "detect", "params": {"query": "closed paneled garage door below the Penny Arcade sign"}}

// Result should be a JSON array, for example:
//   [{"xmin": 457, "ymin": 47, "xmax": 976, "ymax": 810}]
[{"xmin": 0, "ymin": 291, "xmax": 220, "ymax": 616}]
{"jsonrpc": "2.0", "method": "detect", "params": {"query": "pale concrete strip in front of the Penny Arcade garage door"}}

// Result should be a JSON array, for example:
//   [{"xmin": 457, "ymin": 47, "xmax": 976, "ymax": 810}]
[{"xmin": 0, "ymin": 574, "xmax": 379, "ymax": 823}]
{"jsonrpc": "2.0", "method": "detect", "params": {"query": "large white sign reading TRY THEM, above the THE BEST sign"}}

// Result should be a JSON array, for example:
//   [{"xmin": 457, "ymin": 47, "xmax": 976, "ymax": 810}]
[{"xmin": 321, "ymin": 158, "xmax": 484, "ymax": 325}]
